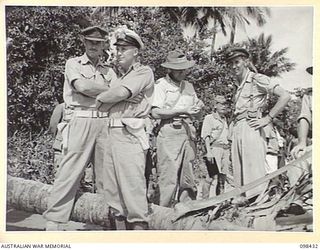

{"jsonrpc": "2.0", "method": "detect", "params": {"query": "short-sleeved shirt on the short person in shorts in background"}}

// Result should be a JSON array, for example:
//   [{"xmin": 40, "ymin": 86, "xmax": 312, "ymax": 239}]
[{"xmin": 201, "ymin": 113, "xmax": 229, "ymax": 144}]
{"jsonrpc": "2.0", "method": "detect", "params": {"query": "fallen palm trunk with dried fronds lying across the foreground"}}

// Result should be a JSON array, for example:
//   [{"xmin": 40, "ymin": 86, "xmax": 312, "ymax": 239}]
[{"xmin": 7, "ymin": 149, "xmax": 312, "ymax": 231}]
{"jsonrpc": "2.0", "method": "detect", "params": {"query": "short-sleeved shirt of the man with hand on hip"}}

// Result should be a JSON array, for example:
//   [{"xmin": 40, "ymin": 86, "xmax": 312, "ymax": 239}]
[{"xmin": 234, "ymin": 70, "xmax": 278, "ymax": 115}]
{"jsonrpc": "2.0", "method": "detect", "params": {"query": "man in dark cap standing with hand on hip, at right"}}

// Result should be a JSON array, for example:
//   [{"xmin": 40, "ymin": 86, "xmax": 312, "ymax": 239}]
[{"xmin": 226, "ymin": 48, "xmax": 290, "ymax": 197}]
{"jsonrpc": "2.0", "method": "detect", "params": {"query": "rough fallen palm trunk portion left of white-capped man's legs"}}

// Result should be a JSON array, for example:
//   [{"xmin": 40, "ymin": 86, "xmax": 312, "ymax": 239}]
[{"xmin": 7, "ymin": 175, "xmax": 110, "ymax": 228}]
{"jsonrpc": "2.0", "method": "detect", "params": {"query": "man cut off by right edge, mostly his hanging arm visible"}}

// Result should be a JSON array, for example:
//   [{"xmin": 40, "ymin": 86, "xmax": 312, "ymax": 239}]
[{"xmin": 291, "ymin": 67, "xmax": 313, "ymax": 158}]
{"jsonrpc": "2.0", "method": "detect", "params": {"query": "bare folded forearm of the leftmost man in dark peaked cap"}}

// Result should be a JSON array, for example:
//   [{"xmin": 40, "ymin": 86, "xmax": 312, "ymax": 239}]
[{"xmin": 74, "ymin": 79, "xmax": 109, "ymax": 97}]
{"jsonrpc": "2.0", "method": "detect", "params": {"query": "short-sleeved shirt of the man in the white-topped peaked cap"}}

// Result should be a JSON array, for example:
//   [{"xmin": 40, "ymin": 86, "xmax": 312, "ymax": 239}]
[{"xmin": 109, "ymin": 63, "xmax": 154, "ymax": 118}]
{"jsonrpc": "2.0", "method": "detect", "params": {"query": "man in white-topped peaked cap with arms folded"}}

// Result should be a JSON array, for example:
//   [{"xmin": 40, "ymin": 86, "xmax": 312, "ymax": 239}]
[{"xmin": 96, "ymin": 29, "xmax": 154, "ymax": 230}]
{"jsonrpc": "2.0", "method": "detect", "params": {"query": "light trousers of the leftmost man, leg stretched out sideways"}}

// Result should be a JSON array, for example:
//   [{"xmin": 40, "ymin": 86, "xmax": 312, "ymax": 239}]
[{"xmin": 43, "ymin": 117, "xmax": 108, "ymax": 223}]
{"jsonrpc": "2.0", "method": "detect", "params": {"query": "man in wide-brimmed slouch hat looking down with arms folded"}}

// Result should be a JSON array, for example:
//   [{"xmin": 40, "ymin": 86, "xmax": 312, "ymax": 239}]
[{"xmin": 151, "ymin": 50, "xmax": 203, "ymax": 207}]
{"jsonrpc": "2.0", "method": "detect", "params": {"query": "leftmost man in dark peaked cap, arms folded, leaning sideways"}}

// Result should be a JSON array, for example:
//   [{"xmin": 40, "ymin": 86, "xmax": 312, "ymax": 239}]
[{"xmin": 44, "ymin": 26, "xmax": 117, "ymax": 231}]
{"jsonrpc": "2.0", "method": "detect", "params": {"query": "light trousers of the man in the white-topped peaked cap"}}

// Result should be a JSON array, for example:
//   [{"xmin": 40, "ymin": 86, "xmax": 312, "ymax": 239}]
[{"xmin": 96, "ymin": 126, "xmax": 148, "ymax": 223}]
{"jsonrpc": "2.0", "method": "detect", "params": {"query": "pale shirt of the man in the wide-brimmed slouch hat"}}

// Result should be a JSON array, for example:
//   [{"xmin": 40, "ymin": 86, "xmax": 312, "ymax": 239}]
[{"xmin": 152, "ymin": 75, "xmax": 200, "ymax": 109}]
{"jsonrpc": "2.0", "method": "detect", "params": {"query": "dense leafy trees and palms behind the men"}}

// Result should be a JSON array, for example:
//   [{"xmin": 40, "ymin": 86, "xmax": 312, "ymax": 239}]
[{"xmin": 6, "ymin": 6, "xmax": 308, "ymax": 183}]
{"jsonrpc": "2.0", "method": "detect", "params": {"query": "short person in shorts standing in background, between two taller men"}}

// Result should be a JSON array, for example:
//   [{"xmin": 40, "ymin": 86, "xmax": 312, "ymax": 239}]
[{"xmin": 201, "ymin": 95, "xmax": 231, "ymax": 198}]
